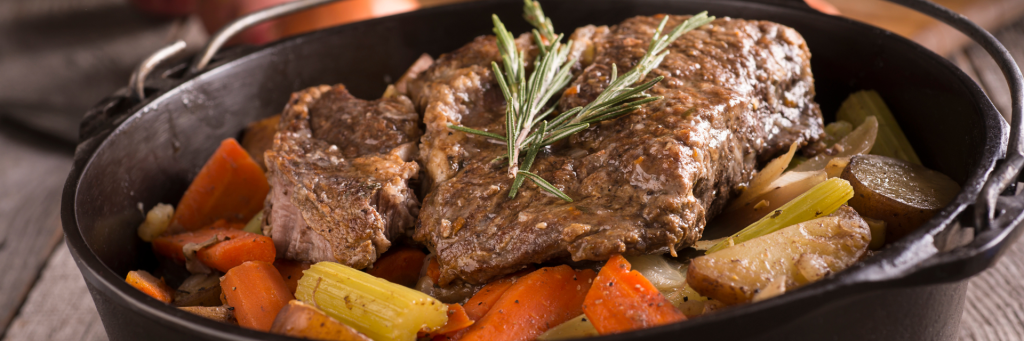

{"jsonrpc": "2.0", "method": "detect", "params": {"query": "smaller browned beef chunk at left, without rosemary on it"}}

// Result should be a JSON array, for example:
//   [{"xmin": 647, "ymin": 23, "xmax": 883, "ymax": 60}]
[{"xmin": 263, "ymin": 85, "xmax": 420, "ymax": 268}]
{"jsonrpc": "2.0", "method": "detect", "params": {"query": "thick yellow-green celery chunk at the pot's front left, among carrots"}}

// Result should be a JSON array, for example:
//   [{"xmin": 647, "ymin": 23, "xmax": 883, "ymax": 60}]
[{"xmin": 295, "ymin": 262, "xmax": 447, "ymax": 341}]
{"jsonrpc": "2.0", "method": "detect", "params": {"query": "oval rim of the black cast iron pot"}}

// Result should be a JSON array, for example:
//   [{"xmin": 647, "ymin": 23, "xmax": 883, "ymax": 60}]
[{"xmin": 61, "ymin": 0, "xmax": 1011, "ymax": 340}]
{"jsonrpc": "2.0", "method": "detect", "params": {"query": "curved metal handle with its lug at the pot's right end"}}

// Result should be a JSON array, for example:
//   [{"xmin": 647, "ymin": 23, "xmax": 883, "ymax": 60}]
[{"xmin": 883, "ymin": 0, "xmax": 1024, "ymax": 286}]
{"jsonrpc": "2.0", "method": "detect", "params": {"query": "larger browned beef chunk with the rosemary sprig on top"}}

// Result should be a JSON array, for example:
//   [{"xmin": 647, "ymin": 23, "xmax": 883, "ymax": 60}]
[{"xmin": 410, "ymin": 16, "xmax": 822, "ymax": 284}]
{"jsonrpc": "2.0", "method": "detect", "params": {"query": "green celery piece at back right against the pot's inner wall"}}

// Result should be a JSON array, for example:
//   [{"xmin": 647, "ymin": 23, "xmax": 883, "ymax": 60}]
[{"xmin": 836, "ymin": 90, "xmax": 921, "ymax": 165}]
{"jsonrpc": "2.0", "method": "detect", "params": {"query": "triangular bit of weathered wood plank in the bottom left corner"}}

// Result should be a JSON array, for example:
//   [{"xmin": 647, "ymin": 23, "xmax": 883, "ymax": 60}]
[{"xmin": 3, "ymin": 243, "xmax": 106, "ymax": 341}]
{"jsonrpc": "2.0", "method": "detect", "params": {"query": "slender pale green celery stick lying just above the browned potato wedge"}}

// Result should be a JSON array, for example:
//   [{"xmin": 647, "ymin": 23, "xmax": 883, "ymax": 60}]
[{"xmin": 705, "ymin": 177, "xmax": 853, "ymax": 254}]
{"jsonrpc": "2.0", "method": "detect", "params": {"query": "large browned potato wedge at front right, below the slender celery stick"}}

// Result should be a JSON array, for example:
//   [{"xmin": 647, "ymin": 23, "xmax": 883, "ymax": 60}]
[{"xmin": 686, "ymin": 206, "xmax": 871, "ymax": 304}]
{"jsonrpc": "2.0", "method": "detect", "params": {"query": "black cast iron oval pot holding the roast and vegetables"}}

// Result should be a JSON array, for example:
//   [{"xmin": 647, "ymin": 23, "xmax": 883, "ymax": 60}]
[{"xmin": 61, "ymin": 0, "xmax": 1024, "ymax": 340}]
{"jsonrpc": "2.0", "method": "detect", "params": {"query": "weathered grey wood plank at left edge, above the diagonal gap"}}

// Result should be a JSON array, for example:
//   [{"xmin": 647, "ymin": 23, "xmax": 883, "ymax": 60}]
[{"xmin": 0, "ymin": 121, "xmax": 73, "ymax": 334}]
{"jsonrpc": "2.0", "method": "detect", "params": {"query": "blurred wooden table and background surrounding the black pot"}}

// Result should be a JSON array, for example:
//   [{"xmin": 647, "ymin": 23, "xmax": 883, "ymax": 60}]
[{"xmin": 0, "ymin": 0, "xmax": 1024, "ymax": 340}]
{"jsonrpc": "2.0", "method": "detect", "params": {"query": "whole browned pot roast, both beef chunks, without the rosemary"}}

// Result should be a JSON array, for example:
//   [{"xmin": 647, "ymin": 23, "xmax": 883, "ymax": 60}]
[{"xmin": 264, "ymin": 15, "xmax": 823, "ymax": 285}]
